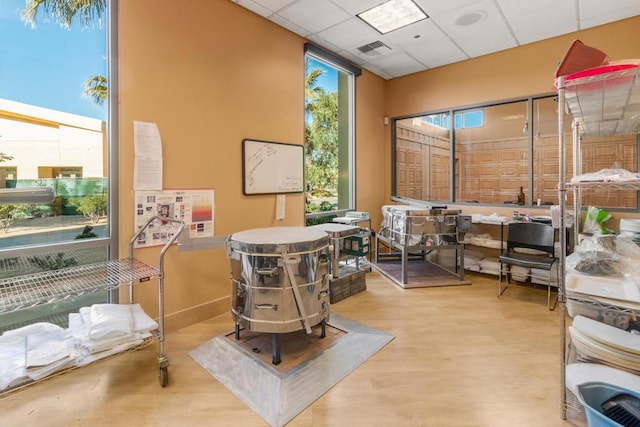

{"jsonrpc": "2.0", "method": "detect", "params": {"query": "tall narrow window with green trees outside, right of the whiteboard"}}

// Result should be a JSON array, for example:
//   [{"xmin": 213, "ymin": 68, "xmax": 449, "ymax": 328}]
[{"xmin": 305, "ymin": 45, "xmax": 360, "ymax": 222}]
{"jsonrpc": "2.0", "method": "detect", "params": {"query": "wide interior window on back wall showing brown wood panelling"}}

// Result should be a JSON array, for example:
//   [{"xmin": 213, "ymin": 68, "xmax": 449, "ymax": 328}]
[{"xmin": 393, "ymin": 96, "xmax": 638, "ymax": 210}]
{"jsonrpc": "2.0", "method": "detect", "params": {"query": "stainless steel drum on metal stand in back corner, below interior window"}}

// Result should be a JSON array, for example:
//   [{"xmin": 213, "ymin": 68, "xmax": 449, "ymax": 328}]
[{"xmin": 390, "ymin": 206, "xmax": 460, "ymax": 246}]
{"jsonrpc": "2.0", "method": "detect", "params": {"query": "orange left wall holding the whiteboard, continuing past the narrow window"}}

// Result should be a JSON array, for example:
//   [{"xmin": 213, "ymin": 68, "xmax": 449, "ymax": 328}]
[{"xmin": 118, "ymin": 0, "xmax": 386, "ymax": 328}]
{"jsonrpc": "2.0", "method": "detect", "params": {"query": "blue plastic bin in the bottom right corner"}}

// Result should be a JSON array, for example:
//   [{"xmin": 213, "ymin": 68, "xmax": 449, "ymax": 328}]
[{"xmin": 578, "ymin": 382, "xmax": 640, "ymax": 427}]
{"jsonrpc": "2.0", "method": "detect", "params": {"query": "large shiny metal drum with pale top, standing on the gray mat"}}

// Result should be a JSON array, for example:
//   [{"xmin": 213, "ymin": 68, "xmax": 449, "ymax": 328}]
[{"xmin": 227, "ymin": 227, "xmax": 329, "ymax": 333}]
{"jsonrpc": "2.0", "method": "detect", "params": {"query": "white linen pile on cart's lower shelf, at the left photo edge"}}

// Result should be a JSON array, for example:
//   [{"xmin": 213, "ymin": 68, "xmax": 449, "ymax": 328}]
[{"xmin": 0, "ymin": 322, "xmax": 76, "ymax": 391}]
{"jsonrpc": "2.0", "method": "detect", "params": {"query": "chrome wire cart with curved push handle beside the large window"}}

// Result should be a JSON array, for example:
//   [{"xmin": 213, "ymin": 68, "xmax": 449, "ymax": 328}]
[{"xmin": 0, "ymin": 216, "xmax": 185, "ymax": 392}]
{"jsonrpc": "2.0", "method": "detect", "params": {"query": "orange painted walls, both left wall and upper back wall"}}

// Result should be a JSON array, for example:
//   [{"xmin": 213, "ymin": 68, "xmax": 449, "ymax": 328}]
[{"xmin": 118, "ymin": 0, "xmax": 640, "ymax": 329}]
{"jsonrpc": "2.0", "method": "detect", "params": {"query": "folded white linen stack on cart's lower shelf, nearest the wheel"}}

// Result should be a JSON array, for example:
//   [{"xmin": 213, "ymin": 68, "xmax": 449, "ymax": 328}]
[{"xmin": 69, "ymin": 304, "xmax": 158, "ymax": 366}]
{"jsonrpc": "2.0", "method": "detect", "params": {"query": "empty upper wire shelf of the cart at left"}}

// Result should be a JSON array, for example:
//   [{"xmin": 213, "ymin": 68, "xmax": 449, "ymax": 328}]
[{"xmin": 0, "ymin": 258, "xmax": 160, "ymax": 313}]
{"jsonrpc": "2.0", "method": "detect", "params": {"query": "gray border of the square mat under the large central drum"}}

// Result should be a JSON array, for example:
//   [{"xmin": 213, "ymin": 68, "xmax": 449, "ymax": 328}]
[{"xmin": 189, "ymin": 314, "xmax": 394, "ymax": 426}]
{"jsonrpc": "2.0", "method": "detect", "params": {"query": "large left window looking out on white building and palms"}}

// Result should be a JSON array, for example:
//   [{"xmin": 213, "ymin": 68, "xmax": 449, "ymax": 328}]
[{"xmin": 0, "ymin": 0, "xmax": 117, "ymax": 332}]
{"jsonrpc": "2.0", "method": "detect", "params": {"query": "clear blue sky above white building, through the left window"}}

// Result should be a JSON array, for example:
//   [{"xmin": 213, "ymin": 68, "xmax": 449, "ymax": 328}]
[{"xmin": 0, "ymin": 0, "xmax": 107, "ymax": 120}]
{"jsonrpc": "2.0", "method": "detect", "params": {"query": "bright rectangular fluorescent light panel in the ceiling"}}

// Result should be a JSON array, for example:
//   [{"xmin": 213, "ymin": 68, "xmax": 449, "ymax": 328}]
[{"xmin": 357, "ymin": 0, "xmax": 429, "ymax": 34}]
